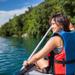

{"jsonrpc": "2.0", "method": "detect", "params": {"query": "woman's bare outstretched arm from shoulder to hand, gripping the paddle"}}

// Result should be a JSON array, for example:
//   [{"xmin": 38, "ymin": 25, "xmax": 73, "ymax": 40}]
[{"xmin": 23, "ymin": 36, "xmax": 63, "ymax": 66}]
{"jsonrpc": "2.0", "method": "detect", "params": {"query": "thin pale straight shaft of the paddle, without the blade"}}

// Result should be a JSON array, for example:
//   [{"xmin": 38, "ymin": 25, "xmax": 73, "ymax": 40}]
[{"xmin": 20, "ymin": 27, "xmax": 51, "ymax": 70}]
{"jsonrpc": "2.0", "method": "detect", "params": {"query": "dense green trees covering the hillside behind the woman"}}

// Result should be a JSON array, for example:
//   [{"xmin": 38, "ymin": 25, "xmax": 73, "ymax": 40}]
[{"xmin": 0, "ymin": 0, "xmax": 75, "ymax": 37}]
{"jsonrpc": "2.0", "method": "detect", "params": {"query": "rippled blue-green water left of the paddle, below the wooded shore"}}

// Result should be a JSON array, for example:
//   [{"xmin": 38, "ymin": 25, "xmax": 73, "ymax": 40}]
[{"xmin": 0, "ymin": 37, "xmax": 45, "ymax": 75}]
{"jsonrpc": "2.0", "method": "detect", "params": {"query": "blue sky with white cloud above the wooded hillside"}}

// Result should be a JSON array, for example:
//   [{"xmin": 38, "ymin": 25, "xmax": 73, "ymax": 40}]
[{"xmin": 0, "ymin": 0, "xmax": 44, "ymax": 26}]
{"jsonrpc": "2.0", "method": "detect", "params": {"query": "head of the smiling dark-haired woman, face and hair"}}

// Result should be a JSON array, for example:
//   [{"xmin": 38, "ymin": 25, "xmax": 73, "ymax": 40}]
[{"xmin": 49, "ymin": 13, "xmax": 70, "ymax": 32}]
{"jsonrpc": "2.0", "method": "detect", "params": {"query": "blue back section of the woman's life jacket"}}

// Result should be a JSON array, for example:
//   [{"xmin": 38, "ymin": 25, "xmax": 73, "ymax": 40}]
[{"xmin": 63, "ymin": 31, "xmax": 75, "ymax": 75}]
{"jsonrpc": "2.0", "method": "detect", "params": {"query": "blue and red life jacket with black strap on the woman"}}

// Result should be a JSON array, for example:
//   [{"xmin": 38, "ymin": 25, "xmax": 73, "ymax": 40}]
[{"xmin": 54, "ymin": 31, "xmax": 75, "ymax": 75}]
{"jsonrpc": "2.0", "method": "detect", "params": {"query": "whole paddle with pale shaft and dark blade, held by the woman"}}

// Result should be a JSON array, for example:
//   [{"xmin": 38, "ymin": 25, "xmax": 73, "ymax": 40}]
[{"xmin": 19, "ymin": 27, "xmax": 51, "ymax": 75}]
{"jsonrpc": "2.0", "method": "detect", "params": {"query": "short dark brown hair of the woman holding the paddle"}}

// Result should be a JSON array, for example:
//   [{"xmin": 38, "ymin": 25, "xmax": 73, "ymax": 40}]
[{"xmin": 51, "ymin": 13, "xmax": 70, "ymax": 31}]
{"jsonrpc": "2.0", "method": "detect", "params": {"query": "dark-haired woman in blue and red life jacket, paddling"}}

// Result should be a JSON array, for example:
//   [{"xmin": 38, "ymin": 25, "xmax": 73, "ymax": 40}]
[{"xmin": 23, "ymin": 13, "xmax": 75, "ymax": 75}]
